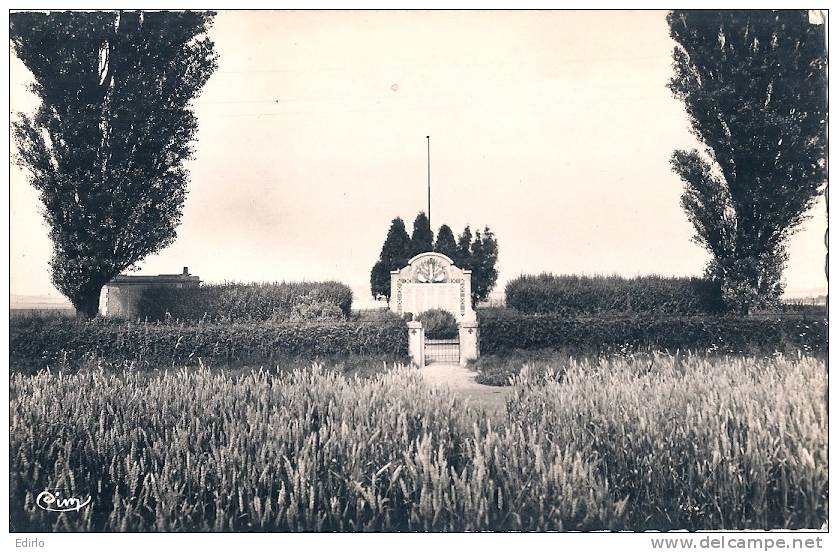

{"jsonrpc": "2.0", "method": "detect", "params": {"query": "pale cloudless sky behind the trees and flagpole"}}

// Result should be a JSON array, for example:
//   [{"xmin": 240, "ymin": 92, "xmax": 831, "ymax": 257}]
[{"xmin": 10, "ymin": 11, "xmax": 826, "ymax": 306}]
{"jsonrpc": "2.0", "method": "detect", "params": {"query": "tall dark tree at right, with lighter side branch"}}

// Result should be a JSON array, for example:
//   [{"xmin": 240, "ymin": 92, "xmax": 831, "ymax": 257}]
[{"xmin": 667, "ymin": 10, "xmax": 827, "ymax": 312}]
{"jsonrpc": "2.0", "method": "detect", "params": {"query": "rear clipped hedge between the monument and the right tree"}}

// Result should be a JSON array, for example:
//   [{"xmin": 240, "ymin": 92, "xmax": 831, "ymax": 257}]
[{"xmin": 506, "ymin": 273, "xmax": 724, "ymax": 316}]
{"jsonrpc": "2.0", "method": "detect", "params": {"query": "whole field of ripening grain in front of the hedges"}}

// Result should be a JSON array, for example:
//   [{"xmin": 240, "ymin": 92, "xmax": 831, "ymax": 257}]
[{"xmin": 10, "ymin": 355, "xmax": 828, "ymax": 531}]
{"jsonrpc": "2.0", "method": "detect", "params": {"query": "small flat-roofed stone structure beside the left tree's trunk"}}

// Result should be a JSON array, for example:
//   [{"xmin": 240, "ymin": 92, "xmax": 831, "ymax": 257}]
[{"xmin": 99, "ymin": 266, "xmax": 201, "ymax": 318}]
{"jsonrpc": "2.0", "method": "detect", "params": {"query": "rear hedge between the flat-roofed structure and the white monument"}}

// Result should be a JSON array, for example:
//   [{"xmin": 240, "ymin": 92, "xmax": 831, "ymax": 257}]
[{"xmin": 138, "ymin": 282, "xmax": 352, "ymax": 322}]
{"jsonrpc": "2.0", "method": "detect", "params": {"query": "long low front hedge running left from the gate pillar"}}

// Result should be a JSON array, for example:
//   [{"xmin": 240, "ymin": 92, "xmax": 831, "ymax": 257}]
[{"xmin": 9, "ymin": 318, "xmax": 407, "ymax": 368}]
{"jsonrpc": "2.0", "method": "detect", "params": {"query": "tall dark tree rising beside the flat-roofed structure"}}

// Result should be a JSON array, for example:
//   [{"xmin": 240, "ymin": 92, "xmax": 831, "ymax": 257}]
[{"xmin": 9, "ymin": 11, "xmax": 217, "ymax": 316}]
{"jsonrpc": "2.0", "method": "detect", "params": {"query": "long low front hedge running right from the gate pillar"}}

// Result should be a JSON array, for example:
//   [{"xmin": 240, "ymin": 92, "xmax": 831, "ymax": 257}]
[{"xmin": 480, "ymin": 313, "xmax": 828, "ymax": 354}]
